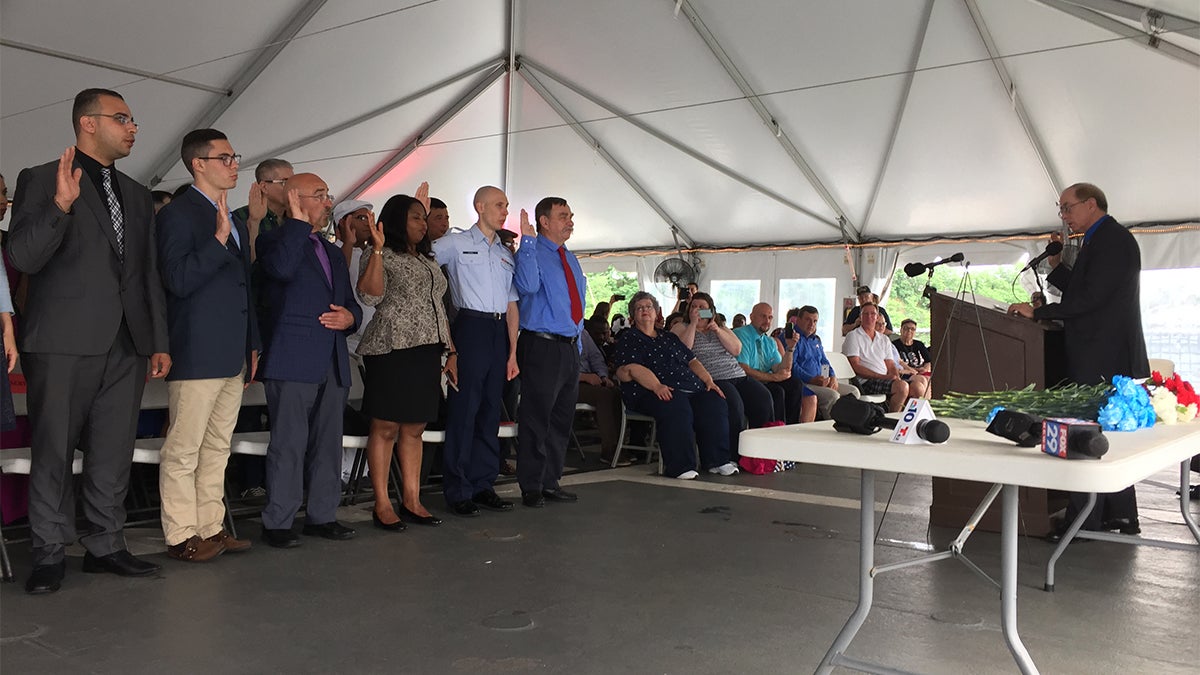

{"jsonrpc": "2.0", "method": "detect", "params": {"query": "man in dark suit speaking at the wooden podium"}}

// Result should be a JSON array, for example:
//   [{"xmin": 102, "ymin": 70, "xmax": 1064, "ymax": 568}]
[{"xmin": 1008, "ymin": 183, "xmax": 1150, "ymax": 538}]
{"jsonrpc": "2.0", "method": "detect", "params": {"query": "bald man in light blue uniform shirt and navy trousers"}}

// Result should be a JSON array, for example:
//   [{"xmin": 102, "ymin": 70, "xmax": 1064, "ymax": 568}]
[{"xmin": 433, "ymin": 185, "xmax": 520, "ymax": 515}]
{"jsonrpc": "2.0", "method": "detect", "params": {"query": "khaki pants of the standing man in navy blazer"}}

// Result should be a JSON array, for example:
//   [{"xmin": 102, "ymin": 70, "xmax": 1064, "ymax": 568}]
[{"xmin": 158, "ymin": 370, "xmax": 245, "ymax": 546}]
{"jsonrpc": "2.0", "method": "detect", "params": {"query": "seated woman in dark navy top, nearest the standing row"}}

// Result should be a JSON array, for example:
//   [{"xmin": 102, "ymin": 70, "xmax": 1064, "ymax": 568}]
[{"xmin": 613, "ymin": 292, "xmax": 738, "ymax": 480}]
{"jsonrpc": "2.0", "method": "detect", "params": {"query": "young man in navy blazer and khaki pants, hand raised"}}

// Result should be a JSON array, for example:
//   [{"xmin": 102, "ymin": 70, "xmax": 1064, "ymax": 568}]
[{"xmin": 156, "ymin": 129, "xmax": 262, "ymax": 562}]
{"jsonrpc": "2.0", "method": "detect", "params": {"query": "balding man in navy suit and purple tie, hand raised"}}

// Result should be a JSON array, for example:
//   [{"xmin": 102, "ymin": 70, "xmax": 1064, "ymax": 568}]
[{"xmin": 256, "ymin": 173, "xmax": 362, "ymax": 548}]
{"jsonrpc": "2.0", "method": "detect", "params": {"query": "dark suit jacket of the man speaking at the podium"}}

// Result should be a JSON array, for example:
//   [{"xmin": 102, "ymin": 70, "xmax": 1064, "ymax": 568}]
[{"xmin": 1033, "ymin": 216, "xmax": 1150, "ymax": 384}]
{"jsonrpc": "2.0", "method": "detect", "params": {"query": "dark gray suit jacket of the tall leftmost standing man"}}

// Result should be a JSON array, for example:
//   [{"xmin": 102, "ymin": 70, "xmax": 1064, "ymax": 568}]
[{"xmin": 8, "ymin": 160, "xmax": 168, "ymax": 356}]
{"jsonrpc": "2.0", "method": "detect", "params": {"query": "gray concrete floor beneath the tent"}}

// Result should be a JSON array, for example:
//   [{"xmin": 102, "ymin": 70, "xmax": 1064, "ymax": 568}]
[{"xmin": 0, "ymin": 448, "xmax": 1200, "ymax": 674}]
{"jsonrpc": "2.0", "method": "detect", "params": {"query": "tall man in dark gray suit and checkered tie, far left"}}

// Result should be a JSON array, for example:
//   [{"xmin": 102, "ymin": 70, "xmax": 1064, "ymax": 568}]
[{"xmin": 8, "ymin": 89, "xmax": 170, "ymax": 593}]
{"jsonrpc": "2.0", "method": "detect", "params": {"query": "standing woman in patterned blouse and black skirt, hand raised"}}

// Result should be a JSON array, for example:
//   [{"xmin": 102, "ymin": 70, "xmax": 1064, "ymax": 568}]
[{"xmin": 358, "ymin": 184, "xmax": 457, "ymax": 531}]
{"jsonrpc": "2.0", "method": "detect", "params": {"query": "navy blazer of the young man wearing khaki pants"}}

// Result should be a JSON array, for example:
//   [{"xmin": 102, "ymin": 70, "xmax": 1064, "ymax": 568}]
[{"xmin": 157, "ymin": 189, "xmax": 262, "ymax": 380}]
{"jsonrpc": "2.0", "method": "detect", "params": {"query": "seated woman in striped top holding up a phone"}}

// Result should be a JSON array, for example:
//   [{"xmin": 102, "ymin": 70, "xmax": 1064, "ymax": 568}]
[{"xmin": 672, "ymin": 292, "xmax": 774, "ymax": 461}]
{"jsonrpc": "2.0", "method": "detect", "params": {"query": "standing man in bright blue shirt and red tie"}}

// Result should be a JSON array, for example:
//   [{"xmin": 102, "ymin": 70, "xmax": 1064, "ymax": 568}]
[{"xmin": 516, "ymin": 197, "xmax": 587, "ymax": 507}]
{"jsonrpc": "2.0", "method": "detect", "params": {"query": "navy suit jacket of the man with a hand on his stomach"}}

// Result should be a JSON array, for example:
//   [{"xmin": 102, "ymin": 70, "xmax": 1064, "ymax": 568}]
[{"xmin": 256, "ymin": 219, "xmax": 362, "ymax": 387}]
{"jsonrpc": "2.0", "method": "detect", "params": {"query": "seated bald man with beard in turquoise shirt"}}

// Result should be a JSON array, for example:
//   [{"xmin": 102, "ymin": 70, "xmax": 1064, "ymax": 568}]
[{"xmin": 733, "ymin": 303, "xmax": 817, "ymax": 424}]
